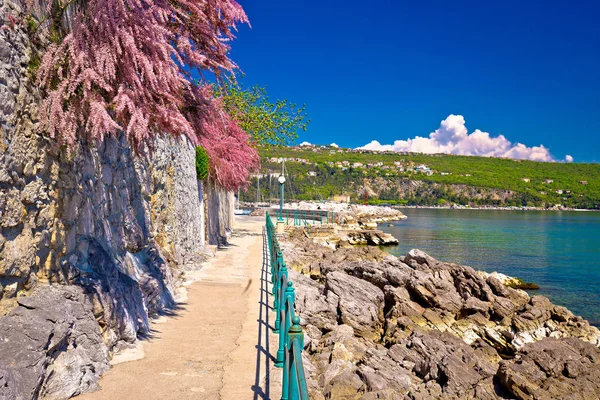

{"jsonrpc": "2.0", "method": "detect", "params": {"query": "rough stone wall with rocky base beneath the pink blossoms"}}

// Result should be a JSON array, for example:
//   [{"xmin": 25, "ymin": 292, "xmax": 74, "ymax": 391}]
[{"xmin": 0, "ymin": 0, "xmax": 204, "ymax": 399}]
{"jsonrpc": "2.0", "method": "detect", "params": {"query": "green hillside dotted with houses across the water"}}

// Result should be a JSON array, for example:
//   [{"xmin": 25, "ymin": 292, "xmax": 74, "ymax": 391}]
[{"xmin": 243, "ymin": 146, "xmax": 600, "ymax": 209}]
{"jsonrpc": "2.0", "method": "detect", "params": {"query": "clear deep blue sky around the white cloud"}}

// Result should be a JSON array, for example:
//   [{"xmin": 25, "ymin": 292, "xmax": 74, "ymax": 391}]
[{"xmin": 231, "ymin": 0, "xmax": 600, "ymax": 162}]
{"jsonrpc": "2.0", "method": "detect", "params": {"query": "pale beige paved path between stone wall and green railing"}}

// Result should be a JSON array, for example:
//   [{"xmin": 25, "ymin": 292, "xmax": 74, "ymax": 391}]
[{"xmin": 77, "ymin": 217, "xmax": 281, "ymax": 400}]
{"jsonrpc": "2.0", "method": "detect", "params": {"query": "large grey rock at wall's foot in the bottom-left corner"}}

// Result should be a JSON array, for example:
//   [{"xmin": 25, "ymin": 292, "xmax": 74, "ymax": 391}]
[{"xmin": 0, "ymin": 286, "xmax": 109, "ymax": 399}]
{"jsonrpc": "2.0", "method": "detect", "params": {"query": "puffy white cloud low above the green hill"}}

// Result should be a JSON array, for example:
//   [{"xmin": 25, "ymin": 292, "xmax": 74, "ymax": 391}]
[{"xmin": 360, "ymin": 114, "xmax": 556, "ymax": 161}]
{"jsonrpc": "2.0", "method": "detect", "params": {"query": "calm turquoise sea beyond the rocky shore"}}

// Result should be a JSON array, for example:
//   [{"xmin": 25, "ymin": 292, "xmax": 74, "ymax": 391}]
[{"xmin": 380, "ymin": 209, "xmax": 600, "ymax": 326}]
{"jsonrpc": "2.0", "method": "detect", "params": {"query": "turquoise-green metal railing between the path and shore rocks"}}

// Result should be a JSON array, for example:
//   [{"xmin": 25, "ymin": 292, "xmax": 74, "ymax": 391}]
[{"xmin": 266, "ymin": 213, "xmax": 308, "ymax": 400}]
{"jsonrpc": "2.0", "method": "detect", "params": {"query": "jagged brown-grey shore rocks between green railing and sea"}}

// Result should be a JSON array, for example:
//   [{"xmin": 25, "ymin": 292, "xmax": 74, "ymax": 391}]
[{"xmin": 282, "ymin": 230, "xmax": 600, "ymax": 399}]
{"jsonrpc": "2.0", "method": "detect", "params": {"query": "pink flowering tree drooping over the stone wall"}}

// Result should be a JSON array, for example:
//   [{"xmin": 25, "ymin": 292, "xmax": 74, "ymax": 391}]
[{"xmin": 31, "ymin": 0, "xmax": 258, "ymax": 189}]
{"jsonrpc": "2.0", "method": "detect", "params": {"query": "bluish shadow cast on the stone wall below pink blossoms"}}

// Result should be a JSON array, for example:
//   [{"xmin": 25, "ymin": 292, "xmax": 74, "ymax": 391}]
[{"xmin": 52, "ymin": 133, "xmax": 180, "ymax": 348}]
